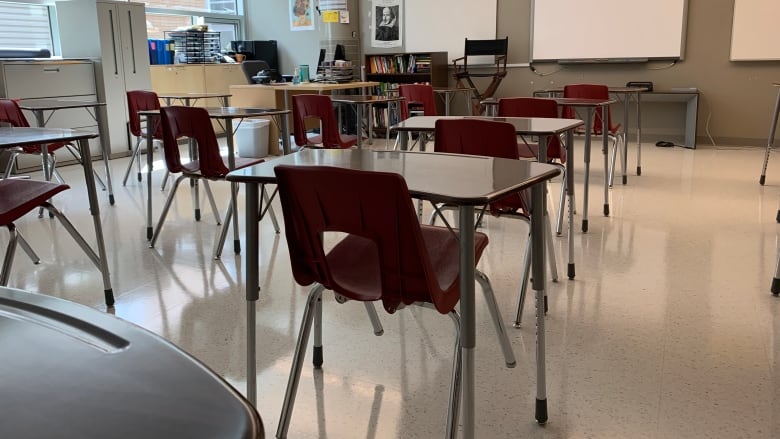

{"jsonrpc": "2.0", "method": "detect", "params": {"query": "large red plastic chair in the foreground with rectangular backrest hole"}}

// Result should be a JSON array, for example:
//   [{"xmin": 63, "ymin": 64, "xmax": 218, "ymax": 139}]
[{"xmin": 275, "ymin": 166, "xmax": 514, "ymax": 437}]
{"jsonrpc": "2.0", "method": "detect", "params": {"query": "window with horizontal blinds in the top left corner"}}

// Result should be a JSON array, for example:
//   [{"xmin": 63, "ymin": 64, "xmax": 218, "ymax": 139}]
[{"xmin": 0, "ymin": 2, "xmax": 54, "ymax": 53}]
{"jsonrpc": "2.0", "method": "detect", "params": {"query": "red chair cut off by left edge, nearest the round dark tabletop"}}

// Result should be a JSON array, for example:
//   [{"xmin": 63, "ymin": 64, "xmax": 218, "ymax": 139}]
[{"xmin": 0, "ymin": 179, "xmax": 99, "ymax": 286}]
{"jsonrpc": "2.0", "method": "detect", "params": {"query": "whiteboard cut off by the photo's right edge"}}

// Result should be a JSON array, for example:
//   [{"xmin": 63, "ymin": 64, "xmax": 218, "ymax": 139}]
[{"xmin": 730, "ymin": 0, "xmax": 780, "ymax": 61}]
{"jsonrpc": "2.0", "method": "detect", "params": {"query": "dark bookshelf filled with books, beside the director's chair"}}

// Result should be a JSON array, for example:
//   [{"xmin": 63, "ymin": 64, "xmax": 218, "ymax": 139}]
[{"xmin": 364, "ymin": 52, "xmax": 449, "ymax": 133}]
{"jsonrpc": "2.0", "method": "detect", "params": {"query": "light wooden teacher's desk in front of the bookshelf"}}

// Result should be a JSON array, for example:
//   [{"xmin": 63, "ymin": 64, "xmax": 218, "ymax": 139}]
[{"xmin": 230, "ymin": 81, "xmax": 379, "ymax": 154}]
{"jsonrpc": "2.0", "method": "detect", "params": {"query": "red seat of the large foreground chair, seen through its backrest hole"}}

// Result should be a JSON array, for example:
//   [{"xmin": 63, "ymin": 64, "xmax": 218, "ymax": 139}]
[{"xmin": 326, "ymin": 225, "xmax": 488, "ymax": 306}]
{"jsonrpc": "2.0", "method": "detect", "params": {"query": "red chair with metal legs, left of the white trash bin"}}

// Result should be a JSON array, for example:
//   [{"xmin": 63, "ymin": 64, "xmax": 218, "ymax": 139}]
[{"xmin": 149, "ymin": 106, "xmax": 270, "ymax": 258}]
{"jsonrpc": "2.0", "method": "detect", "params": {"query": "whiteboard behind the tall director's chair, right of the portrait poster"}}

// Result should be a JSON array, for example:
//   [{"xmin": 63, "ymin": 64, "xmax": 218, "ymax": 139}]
[{"xmin": 404, "ymin": 0, "xmax": 496, "ymax": 61}]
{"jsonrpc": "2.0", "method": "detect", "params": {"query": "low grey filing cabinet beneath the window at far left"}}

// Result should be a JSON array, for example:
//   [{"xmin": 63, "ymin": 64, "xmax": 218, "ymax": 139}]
[{"xmin": 0, "ymin": 59, "xmax": 100, "ymax": 171}]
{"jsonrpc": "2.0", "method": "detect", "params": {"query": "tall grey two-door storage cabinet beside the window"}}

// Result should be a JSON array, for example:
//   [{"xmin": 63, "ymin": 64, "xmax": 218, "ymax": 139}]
[{"xmin": 56, "ymin": 0, "xmax": 151, "ymax": 157}]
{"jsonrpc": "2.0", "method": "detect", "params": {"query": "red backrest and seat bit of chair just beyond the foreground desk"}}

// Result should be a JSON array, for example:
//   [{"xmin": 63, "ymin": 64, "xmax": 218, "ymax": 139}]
[{"xmin": 434, "ymin": 118, "xmax": 529, "ymax": 215}]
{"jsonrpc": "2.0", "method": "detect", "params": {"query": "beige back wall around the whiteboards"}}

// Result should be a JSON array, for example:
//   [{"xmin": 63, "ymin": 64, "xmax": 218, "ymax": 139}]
[{"xmin": 247, "ymin": 0, "xmax": 780, "ymax": 147}]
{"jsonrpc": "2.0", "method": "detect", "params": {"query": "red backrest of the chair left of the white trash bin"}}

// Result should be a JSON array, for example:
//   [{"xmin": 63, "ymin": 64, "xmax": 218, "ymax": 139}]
[{"xmin": 160, "ymin": 106, "xmax": 228, "ymax": 178}]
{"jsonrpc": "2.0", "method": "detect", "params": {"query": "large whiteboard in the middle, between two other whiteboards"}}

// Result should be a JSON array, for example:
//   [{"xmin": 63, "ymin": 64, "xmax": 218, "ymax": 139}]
[{"xmin": 531, "ymin": 0, "xmax": 688, "ymax": 62}]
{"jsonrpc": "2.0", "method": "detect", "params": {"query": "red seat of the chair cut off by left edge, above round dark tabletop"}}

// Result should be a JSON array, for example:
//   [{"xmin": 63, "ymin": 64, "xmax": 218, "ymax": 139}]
[{"xmin": 0, "ymin": 179, "xmax": 70, "ymax": 225}]
